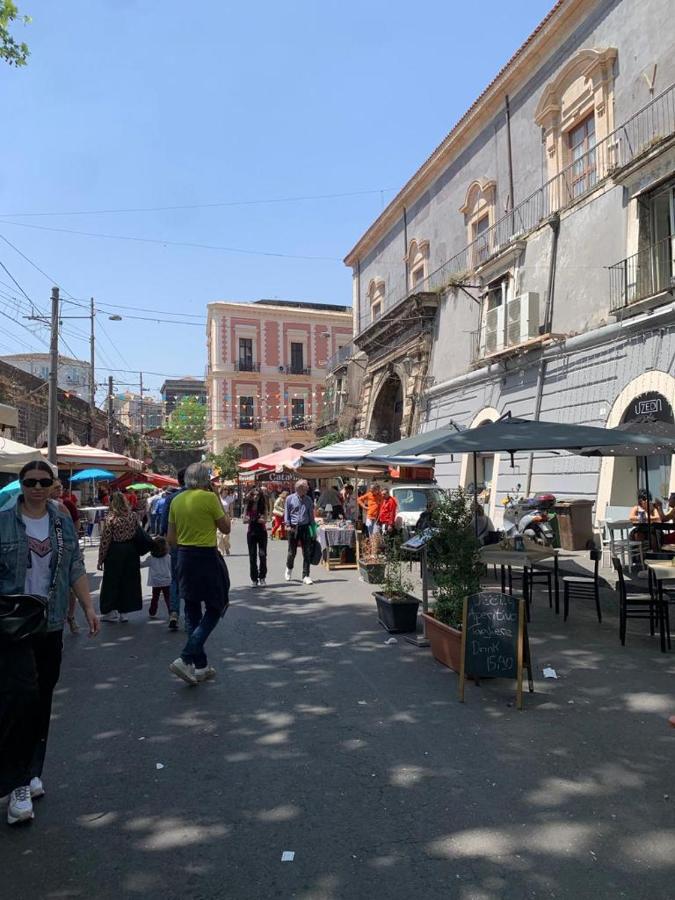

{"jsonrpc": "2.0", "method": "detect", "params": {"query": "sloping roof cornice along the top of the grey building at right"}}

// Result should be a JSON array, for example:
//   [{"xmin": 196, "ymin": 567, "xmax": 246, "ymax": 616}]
[{"xmin": 344, "ymin": 0, "xmax": 600, "ymax": 266}]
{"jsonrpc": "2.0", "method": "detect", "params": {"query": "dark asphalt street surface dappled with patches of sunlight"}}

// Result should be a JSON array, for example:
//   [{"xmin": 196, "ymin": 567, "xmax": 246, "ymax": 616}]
[{"xmin": 0, "ymin": 524, "xmax": 675, "ymax": 900}]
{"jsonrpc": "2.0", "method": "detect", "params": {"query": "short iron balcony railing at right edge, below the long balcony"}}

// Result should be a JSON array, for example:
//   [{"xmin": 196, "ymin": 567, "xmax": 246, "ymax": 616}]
[{"xmin": 609, "ymin": 237, "xmax": 675, "ymax": 312}]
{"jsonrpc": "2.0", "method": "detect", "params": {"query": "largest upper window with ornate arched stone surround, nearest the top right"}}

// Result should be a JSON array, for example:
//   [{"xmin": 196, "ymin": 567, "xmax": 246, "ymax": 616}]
[{"xmin": 534, "ymin": 47, "xmax": 617, "ymax": 199}]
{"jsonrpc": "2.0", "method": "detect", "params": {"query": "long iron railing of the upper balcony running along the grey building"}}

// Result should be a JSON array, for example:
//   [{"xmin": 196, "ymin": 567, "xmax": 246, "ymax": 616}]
[{"xmin": 354, "ymin": 84, "xmax": 675, "ymax": 336}]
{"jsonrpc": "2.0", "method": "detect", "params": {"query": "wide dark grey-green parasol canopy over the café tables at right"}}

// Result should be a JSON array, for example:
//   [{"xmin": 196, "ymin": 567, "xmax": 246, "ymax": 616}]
[{"xmin": 374, "ymin": 417, "xmax": 675, "ymax": 460}]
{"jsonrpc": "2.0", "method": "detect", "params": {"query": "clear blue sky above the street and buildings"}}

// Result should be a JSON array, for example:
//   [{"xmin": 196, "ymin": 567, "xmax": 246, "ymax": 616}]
[{"xmin": 0, "ymin": 0, "xmax": 552, "ymax": 400}]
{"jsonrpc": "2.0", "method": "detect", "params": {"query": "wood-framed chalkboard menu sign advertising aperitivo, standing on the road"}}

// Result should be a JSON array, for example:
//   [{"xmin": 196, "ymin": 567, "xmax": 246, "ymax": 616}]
[{"xmin": 460, "ymin": 591, "xmax": 534, "ymax": 709}]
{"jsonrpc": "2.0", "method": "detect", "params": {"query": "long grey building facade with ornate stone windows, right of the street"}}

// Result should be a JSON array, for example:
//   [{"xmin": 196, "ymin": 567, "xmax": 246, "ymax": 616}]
[{"xmin": 338, "ymin": 0, "xmax": 675, "ymax": 522}]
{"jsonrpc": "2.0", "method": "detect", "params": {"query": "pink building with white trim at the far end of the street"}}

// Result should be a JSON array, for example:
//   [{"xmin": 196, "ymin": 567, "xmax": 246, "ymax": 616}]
[{"xmin": 206, "ymin": 300, "xmax": 352, "ymax": 459}]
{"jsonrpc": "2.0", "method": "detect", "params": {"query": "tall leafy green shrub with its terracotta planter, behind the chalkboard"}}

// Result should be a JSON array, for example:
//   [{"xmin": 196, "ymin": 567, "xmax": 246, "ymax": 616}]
[{"xmin": 424, "ymin": 488, "xmax": 480, "ymax": 672}]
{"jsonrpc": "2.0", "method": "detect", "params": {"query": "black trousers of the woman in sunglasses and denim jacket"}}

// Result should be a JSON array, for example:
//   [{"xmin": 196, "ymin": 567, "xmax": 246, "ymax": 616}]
[{"xmin": 0, "ymin": 631, "xmax": 63, "ymax": 796}]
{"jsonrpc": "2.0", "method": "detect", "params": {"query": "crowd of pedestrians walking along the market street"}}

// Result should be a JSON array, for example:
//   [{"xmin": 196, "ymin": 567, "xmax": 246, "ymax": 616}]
[{"xmin": 0, "ymin": 462, "xmax": 396, "ymax": 824}]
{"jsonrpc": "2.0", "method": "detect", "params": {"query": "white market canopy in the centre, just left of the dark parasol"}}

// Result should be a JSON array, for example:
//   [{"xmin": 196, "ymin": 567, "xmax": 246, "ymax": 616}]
[{"xmin": 293, "ymin": 438, "xmax": 434, "ymax": 478}]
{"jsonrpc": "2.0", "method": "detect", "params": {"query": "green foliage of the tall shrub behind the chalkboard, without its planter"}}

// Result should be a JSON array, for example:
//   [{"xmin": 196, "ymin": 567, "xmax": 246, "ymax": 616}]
[{"xmin": 428, "ymin": 488, "xmax": 481, "ymax": 628}]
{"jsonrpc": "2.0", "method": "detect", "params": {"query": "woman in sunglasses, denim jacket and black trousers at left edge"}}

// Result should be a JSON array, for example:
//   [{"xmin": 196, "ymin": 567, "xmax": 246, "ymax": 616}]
[{"xmin": 0, "ymin": 461, "xmax": 99, "ymax": 825}]
